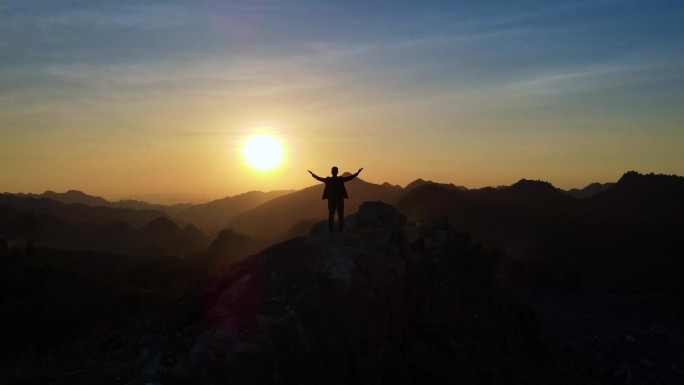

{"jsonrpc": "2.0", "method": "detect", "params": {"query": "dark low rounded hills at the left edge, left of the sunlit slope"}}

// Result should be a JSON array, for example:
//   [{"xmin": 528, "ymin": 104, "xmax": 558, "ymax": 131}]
[{"xmin": 0, "ymin": 195, "xmax": 209, "ymax": 256}]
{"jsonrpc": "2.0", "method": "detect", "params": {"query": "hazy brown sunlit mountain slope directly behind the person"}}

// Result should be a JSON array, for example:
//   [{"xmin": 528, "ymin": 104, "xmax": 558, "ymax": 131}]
[{"xmin": 227, "ymin": 178, "xmax": 403, "ymax": 241}]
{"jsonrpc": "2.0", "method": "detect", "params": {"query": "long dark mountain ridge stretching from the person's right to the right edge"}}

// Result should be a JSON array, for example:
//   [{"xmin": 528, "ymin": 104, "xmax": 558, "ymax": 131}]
[{"xmin": 397, "ymin": 172, "xmax": 684, "ymax": 293}]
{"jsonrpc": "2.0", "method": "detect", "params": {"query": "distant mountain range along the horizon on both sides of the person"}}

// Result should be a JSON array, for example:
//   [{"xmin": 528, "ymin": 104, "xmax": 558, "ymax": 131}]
[{"xmin": 0, "ymin": 171, "xmax": 684, "ymax": 291}]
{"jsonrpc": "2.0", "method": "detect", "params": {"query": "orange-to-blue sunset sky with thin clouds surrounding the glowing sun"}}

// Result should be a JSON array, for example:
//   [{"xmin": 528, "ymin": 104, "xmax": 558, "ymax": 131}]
[{"xmin": 0, "ymin": 0, "xmax": 684, "ymax": 199}]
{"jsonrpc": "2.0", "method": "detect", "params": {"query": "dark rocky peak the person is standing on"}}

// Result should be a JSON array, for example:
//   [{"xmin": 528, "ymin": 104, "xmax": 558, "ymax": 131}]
[{"xmin": 136, "ymin": 202, "xmax": 567, "ymax": 385}]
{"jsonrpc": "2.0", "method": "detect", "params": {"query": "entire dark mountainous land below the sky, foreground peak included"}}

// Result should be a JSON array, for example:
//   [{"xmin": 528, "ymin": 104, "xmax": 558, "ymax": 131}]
[{"xmin": 0, "ymin": 172, "xmax": 684, "ymax": 384}]
